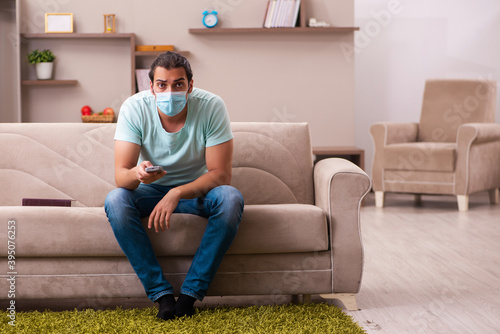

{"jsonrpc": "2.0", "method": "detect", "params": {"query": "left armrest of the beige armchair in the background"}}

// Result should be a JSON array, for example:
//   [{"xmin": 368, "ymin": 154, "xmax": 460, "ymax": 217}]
[{"xmin": 370, "ymin": 122, "xmax": 418, "ymax": 191}]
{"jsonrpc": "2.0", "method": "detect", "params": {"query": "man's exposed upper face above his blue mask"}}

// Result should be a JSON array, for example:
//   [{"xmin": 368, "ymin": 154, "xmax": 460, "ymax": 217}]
[{"xmin": 151, "ymin": 66, "xmax": 193, "ymax": 94}]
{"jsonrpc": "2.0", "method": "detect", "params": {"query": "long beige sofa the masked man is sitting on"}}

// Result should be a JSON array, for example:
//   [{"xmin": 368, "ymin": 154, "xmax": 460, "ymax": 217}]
[{"xmin": 0, "ymin": 123, "xmax": 371, "ymax": 309}]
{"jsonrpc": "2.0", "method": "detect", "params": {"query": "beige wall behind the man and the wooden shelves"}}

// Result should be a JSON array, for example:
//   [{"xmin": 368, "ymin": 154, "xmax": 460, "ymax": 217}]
[{"xmin": 15, "ymin": 0, "xmax": 354, "ymax": 146}]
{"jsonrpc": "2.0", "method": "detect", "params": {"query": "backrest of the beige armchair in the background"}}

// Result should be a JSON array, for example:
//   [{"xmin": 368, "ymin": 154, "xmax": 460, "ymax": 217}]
[{"xmin": 418, "ymin": 80, "xmax": 496, "ymax": 143}]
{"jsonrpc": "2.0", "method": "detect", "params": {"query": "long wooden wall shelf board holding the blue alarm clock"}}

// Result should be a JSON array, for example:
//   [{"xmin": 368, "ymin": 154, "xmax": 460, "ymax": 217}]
[{"xmin": 189, "ymin": 27, "xmax": 359, "ymax": 34}]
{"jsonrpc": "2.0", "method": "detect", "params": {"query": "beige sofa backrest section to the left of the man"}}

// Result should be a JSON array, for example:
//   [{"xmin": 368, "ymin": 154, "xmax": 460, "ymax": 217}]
[{"xmin": 0, "ymin": 123, "xmax": 115, "ymax": 206}]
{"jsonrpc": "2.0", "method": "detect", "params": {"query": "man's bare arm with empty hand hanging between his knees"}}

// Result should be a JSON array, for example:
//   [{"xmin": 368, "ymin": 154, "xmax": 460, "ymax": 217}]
[{"xmin": 148, "ymin": 139, "xmax": 233, "ymax": 232}]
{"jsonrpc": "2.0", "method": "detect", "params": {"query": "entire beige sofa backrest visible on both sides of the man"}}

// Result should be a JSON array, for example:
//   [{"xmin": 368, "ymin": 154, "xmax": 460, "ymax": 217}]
[{"xmin": 0, "ymin": 123, "xmax": 313, "ymax": 207}]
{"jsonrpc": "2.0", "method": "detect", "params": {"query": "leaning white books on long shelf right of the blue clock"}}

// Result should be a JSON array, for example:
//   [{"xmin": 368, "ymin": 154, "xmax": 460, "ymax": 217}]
[{"xmin": 264, "ymin": 0, "xmax": 300, "ymax": 28}]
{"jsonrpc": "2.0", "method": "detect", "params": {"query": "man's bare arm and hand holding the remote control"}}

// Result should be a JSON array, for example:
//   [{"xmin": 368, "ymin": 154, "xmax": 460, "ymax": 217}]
[{"xmin": 115, "ymin": 140, "xmax": 167, "ymax": 190}]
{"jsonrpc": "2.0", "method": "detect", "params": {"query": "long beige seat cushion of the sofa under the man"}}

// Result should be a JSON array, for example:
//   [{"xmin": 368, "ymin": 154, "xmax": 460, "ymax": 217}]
[{"xmin": 0, "ymin": 204, "xmax": 328, "ymax": 257}]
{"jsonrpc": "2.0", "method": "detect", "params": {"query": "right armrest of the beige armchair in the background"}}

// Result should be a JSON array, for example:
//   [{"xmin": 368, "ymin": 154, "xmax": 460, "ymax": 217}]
[{"xmin": 455, "ymin": 123, "xmax": 500, "ymax": 195}]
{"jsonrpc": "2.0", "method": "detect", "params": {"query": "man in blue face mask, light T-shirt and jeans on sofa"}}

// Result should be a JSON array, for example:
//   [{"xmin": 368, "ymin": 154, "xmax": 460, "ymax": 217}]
[{"xmin": 105, "ymin": 52, "xmax": 243, "ymax": 320}]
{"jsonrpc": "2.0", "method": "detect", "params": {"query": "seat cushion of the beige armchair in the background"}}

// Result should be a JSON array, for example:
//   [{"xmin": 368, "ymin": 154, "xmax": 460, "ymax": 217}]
[{"xmin": 383, "ymin": 142, "xmax": 457, "ymax": 172}]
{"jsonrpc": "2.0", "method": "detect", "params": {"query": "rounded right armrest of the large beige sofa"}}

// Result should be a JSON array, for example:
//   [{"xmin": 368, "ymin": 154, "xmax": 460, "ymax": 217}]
[{"xmin": 314, "ymin": 158, "xmax": 371, "ymax": 293}]
